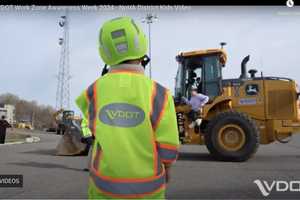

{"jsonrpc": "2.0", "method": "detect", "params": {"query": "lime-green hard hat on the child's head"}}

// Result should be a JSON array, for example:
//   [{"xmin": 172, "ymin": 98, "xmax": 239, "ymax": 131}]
[{"xmin": 99, "ymin": 17, "xmax": 148, "ymax": 66}]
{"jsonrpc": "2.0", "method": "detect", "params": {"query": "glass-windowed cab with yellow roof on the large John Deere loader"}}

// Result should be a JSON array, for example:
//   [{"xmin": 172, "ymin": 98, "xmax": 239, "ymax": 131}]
[{"xmin": 175, "ymin": 49, "xmax": 226, "ymax": 99}]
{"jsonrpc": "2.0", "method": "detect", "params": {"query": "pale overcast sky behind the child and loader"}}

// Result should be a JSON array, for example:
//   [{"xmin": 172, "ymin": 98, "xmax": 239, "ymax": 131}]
[{"xmin": 0, "ymin": 6, "xmax": 300, "ymax": 111}]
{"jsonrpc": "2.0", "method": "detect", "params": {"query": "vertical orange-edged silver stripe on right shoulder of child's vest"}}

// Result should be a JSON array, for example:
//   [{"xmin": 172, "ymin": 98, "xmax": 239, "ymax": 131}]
[{"xmin": 151, "ymin": 83, "xmax": 167, "ymax": 130}]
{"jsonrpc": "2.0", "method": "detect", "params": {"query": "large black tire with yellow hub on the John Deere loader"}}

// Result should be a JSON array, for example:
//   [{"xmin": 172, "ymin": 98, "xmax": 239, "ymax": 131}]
[{"xmin": 205, "ymin": 111, "xmax": 259, "ymax": 162}]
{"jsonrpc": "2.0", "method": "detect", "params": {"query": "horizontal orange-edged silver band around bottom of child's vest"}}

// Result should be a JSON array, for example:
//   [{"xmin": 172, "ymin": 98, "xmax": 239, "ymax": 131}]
[{"xmin": 90, "ymin": 169, "xmax": 165, "ymax": 195}]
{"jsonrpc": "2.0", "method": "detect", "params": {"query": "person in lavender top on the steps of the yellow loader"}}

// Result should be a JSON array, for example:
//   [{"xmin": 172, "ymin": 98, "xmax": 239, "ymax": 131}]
[{"xmin": 182, "ymin": 87, "xmax": 209, "ymax": 128}]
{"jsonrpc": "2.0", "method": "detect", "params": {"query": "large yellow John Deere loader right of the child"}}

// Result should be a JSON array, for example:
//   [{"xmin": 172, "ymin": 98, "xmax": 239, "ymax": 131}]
[{"xmin": 175, "ymin": 44, "xmax": 300, "ymax": 161}]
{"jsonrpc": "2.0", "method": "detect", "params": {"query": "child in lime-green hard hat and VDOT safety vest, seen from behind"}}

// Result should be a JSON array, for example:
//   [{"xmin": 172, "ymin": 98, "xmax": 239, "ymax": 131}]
[{"xmin": 76, "ymin": 17, "xmax": 179, "ymax": 199}]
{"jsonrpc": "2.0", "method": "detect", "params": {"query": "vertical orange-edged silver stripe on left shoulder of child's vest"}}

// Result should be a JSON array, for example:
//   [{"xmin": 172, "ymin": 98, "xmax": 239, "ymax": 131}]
[{"xmin": 87, "ymin": 83, "xmax": 96, "ymax": 134}]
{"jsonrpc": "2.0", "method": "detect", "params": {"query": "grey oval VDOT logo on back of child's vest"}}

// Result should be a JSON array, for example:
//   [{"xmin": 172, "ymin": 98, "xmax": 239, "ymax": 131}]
[{"xmin": 99, "ymin": 103, "xmax": 145, "ymax": 127}]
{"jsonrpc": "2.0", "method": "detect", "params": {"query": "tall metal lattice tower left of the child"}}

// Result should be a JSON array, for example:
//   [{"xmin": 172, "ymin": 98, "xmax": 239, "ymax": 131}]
[{"xmin": 56, "ymin": 11, "xmax": 71, "ymax": 109}]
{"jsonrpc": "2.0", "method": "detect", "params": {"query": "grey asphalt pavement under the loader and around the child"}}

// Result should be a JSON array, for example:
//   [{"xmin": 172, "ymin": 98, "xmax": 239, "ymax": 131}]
[{"xmin": 0, "ymin": 130, "xmax": 300, "ymax": 199}]
